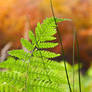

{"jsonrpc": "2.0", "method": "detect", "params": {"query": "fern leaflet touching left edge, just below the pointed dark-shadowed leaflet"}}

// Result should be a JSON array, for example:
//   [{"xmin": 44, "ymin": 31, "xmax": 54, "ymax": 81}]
[{"xmin": 0, "ymin": 57, "xmax": 28, "ymax": 73}]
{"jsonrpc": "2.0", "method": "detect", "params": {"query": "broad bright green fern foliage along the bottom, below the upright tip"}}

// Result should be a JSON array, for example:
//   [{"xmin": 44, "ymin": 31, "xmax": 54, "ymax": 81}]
[{"xmin": 0, "ymin": 57, "xmax": 68, "ymax": 92}]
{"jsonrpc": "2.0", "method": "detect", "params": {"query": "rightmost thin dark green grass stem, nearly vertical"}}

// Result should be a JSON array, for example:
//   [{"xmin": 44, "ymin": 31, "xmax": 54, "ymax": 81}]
[{"xmin": 75, "ymin": 31, "xmax": 81, "ymax": 92}]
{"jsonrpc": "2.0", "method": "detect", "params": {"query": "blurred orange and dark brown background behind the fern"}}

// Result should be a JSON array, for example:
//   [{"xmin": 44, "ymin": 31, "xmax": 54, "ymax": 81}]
[{"xmin": 0, "ymin": 0, "xmax": 92, "ymax": 72}]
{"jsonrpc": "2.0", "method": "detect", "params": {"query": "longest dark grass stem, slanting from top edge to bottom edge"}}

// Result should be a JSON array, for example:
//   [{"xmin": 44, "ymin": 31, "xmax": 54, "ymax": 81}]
[{"xmin": 50, "ymin": 0, "xmax": 72, "ymax": 92}]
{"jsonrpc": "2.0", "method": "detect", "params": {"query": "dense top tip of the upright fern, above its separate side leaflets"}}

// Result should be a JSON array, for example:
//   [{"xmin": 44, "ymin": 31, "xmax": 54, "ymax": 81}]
[{"xmin": 35, "ymin": 17, "xmax": 64, "ymax": 42}]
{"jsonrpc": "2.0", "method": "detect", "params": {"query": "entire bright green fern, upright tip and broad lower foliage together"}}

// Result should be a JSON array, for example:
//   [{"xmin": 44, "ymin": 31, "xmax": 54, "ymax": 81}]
[{"xmin": 0, "ymin": 18, "xmax": 71, "ymax": 92}]
